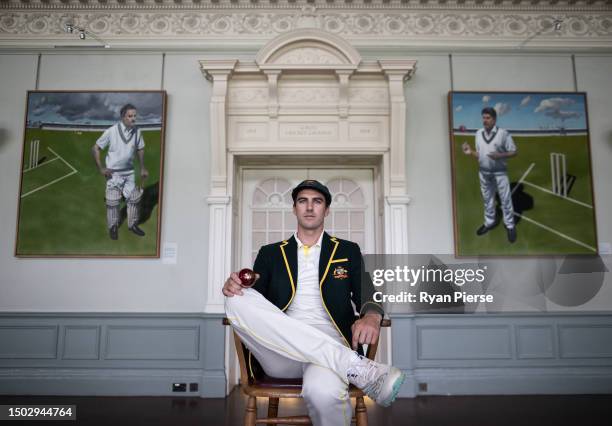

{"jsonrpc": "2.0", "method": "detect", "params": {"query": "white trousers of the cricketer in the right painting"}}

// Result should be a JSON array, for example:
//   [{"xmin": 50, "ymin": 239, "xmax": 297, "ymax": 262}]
[{"xmin": 478, "ymin": 170, "xmax": 514, "ymax": 228}]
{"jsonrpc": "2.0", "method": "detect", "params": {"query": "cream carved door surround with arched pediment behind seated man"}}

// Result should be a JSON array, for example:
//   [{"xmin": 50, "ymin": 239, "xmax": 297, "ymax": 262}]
[{"xmin": 200, "ymin": 29, "xmax": 416, "ymax": 312}]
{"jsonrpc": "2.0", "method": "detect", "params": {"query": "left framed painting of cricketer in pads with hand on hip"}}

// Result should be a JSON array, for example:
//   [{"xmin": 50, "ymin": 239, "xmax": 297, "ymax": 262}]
[{"xmin": 15, "ymin": 91, "xmax": 166, "ymax": 257}]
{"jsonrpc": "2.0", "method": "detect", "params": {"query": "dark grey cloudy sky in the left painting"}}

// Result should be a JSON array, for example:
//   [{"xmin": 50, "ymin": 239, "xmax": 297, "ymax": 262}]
[{"xmin": 28, "ymin": 92, "xmax": 163, "ymax": 125}]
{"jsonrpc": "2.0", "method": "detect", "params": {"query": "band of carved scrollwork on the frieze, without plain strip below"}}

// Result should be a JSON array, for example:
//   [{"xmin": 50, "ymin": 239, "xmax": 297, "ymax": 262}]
[{"xmin": 0, "ymin": 11, "xmax": 612, "ymax": 40}]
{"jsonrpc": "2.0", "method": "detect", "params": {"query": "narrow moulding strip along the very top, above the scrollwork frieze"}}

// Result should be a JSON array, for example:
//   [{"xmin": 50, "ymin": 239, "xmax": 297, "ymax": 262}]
[{"xmin": 0, "ymin": 0, "xmax": 612, "ymax": 12}]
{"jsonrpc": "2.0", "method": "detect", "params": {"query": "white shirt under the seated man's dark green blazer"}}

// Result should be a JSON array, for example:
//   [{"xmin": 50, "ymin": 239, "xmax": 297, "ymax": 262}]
[{"xmin": 285, "ymin": 232, "xmax": 343, "ymax": 343}]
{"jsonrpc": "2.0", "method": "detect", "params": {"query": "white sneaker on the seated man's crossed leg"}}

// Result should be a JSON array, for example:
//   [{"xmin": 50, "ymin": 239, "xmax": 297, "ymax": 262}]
[{"xmin": 346, "ymin": 355, "xmax": 406, "ymax": 407}]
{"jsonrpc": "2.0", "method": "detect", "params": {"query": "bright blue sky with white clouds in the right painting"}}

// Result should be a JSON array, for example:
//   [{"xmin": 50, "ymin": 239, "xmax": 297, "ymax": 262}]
[{"xmin": 452, "ymin": 92, "xmax": 587, "ymax": 130}]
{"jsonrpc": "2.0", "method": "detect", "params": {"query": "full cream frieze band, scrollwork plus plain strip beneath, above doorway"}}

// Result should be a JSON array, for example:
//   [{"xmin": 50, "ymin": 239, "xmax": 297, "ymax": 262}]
[{"xmin": 0, "ymin": 7, "xmax": 612, "ymax": 51}]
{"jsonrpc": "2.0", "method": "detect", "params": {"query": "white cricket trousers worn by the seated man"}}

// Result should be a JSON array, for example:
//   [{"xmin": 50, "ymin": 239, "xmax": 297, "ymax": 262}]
[{"xmin": 225, "ymin": 288, "xmax": 357, "ymax": 426}]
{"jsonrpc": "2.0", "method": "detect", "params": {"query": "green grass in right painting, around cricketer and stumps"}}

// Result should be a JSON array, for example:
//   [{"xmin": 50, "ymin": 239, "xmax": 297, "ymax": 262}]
[{"xmin": 453, "ymin": 134, "xmax": 596, "ymax": 256}]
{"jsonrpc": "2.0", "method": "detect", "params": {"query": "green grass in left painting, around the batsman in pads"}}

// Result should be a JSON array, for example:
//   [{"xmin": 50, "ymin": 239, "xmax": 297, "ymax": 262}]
[{"xmin": 17, "ymin": 129, "xmax": 161, "ymax": 256}]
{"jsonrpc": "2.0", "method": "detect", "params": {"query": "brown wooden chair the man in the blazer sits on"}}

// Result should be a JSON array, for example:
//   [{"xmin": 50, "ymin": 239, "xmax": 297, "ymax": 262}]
[{"xmin": 223, "ymin": 318, "xmax": 391, "ymax": 426}]
